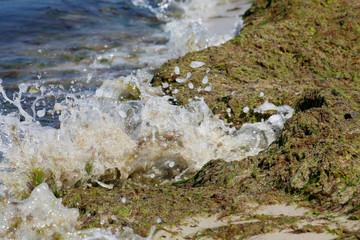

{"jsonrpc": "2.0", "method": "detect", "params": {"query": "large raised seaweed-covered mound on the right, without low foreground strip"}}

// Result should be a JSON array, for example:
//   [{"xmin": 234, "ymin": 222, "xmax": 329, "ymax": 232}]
[{"xmin": 153, "ymin": 0, "xmax": 360, "ymax": 206}]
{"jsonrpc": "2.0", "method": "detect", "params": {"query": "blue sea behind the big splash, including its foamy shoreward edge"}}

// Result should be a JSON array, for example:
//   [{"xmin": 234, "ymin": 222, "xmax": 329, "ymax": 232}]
[{"xmin": 0, "ymin": 0, "xmax": 253, "ymax": 127}]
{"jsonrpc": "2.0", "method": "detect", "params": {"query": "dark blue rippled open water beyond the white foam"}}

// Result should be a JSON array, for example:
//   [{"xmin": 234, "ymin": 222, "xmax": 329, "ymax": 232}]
[{"xmin": 0, "ymin": 0, "xmax": 160, "ymax": 83}]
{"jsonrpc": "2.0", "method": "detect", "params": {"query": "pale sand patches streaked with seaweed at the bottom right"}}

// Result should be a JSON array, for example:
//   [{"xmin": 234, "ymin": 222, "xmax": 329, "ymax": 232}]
[{"xmin": 153, "ymin": 204, "xmax": 360, "ymax": 240}]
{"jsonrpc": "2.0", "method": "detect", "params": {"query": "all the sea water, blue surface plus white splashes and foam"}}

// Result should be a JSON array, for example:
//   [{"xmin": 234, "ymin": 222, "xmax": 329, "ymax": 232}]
[{"xmin": 0, "ymin": 0, "xmax": 293, "ymax": 239}]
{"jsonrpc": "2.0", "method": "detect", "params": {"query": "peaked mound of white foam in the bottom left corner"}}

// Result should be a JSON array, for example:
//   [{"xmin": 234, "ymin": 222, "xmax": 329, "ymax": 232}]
[{"xmin": 0, "ymin": 183, "xmax": 79, "ymax": 239}]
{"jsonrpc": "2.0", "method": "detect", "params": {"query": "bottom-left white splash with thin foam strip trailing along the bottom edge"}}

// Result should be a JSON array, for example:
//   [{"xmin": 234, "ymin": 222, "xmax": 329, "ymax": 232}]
[{"xmin": 0, "ymin": 183, "xmax": 155, "ymax": 240}]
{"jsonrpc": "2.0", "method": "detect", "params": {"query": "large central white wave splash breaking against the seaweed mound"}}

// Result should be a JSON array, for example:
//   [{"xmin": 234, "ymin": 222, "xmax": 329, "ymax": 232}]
[{"xmin": 0, "ymin": 71, "xmax": 293, "ymax": 191}]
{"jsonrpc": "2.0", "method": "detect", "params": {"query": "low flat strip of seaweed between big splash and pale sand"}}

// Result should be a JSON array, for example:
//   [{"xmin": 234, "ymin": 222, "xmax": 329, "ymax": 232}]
[{"xmin": 62, "ymin": 181, "xmax": 291, "ymax": 236}]
